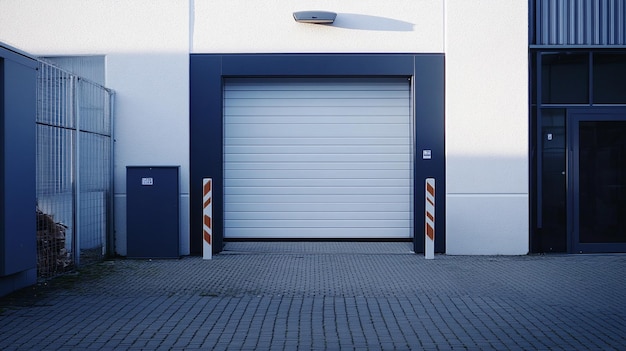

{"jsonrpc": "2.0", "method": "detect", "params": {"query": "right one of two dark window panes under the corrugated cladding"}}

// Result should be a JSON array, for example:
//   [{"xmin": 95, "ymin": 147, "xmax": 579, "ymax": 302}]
[{"xmin": 593, "ymin": 53, "xmax": 626, "ymax": 104}]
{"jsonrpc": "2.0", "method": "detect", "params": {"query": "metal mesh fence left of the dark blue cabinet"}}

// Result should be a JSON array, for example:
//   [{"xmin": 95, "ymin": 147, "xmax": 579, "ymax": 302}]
[{"xmin": 37, "ymin": 61, "xmax": 113, "ymax": 277}]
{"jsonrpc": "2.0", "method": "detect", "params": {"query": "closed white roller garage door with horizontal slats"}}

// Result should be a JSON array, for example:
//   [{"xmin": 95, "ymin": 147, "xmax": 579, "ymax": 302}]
[{"xmin": 224, "ymin": 78, "xmax": 413, "ymax": 239}]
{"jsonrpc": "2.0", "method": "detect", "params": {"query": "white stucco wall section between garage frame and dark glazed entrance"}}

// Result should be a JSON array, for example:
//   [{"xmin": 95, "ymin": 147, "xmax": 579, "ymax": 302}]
[{"xmin": 445, "ymin": 0, "xmax": 529, "ymax": 254}]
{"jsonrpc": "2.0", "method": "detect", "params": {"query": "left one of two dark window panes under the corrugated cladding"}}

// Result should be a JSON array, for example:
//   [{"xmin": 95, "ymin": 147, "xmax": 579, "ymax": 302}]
[{"xmin": 541, "ymin": 52, "xmax": 589, "ymax": 104}]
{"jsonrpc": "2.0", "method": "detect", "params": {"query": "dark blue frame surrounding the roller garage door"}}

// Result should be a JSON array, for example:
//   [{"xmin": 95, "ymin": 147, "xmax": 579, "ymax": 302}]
[{"xmin": 189, "ymin": 54, "xmax": 445, "ymax": 254}]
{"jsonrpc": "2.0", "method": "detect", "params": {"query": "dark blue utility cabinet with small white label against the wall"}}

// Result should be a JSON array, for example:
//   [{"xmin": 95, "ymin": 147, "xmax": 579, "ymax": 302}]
[{"xmin": 126, "ymin": 166, "xmax": 180, "ymax": 258}]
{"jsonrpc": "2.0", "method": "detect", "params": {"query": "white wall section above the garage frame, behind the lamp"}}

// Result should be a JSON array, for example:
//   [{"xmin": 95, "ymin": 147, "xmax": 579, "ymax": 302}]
[{"xmin": 191, "ymin": 0, "xmax": 444, "ymax": 53}]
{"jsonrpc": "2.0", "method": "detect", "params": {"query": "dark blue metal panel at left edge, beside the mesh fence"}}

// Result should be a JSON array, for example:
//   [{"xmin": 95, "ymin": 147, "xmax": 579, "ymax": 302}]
[{"xmin": 0, "ymin": 48, "xmax": 37, "ymax": 283}]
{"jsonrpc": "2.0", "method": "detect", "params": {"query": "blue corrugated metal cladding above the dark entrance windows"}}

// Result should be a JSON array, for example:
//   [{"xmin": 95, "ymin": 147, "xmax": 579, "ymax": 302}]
[{"xmin": 530, "ymin": 0, "xmax": 626, "ymax": 46}]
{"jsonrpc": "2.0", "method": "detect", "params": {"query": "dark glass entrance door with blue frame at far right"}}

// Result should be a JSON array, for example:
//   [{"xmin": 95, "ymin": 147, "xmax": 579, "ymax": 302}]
[{"xmin": 569, "ymin": 113, "xmax": 626, "ymax": 252}]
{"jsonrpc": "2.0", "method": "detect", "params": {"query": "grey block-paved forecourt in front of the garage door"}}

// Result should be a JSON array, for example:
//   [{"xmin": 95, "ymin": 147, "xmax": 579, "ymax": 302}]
[{"xmin": 0, "ymin": 242, "xmax": 626, "ymax": 350}]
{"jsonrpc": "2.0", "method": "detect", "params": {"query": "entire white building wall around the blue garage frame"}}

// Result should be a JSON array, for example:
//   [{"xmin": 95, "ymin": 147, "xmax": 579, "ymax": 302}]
[{"xmin": 0, "ymin": 0, "xmax": 528, "ymax": 255}]
